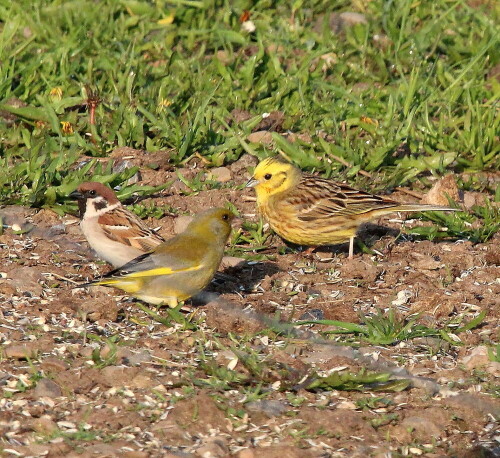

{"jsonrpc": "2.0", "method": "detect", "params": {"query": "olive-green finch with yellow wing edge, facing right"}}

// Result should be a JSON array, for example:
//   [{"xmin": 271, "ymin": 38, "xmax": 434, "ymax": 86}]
[{"xmin": 84, "ymin": 208, "xmax": 234, "ymax": 308}]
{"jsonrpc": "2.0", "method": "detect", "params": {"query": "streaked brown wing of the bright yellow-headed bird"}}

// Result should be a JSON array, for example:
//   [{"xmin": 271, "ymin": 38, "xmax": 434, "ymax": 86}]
[{"xmin": 283, "ymin": 176, "xmax": 398, "ymax": 221}]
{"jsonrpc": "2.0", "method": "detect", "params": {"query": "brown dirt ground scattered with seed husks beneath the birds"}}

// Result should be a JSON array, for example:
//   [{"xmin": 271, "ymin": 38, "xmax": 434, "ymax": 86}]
[{"xmin": 0, "ymin": 153, "xmax": 500, "ymax": 458}]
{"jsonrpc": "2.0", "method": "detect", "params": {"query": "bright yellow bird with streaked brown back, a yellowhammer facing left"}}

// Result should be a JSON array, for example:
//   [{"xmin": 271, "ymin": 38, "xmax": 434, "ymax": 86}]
[{"xmin": 247, "ymin": 157, "xmax": 457, "ymax": 258}]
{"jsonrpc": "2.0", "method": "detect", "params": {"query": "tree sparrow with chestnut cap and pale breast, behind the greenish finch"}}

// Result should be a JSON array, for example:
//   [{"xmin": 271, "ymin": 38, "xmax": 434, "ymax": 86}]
[{"xmin": 70, "ymin": 182, "xmax": 164, "ymax": 268}]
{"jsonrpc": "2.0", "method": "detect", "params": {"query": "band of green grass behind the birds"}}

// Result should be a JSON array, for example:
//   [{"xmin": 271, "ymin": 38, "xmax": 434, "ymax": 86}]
[{"xmin": 0, "ymin": 0, "xmax": 500, "ymax": 206}]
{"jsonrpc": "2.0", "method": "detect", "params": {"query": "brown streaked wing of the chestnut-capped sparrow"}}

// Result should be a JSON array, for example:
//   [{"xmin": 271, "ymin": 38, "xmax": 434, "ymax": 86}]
[{"xmin": 98, "ymin": 207, "xmax": 164, "ymax": 251}]
